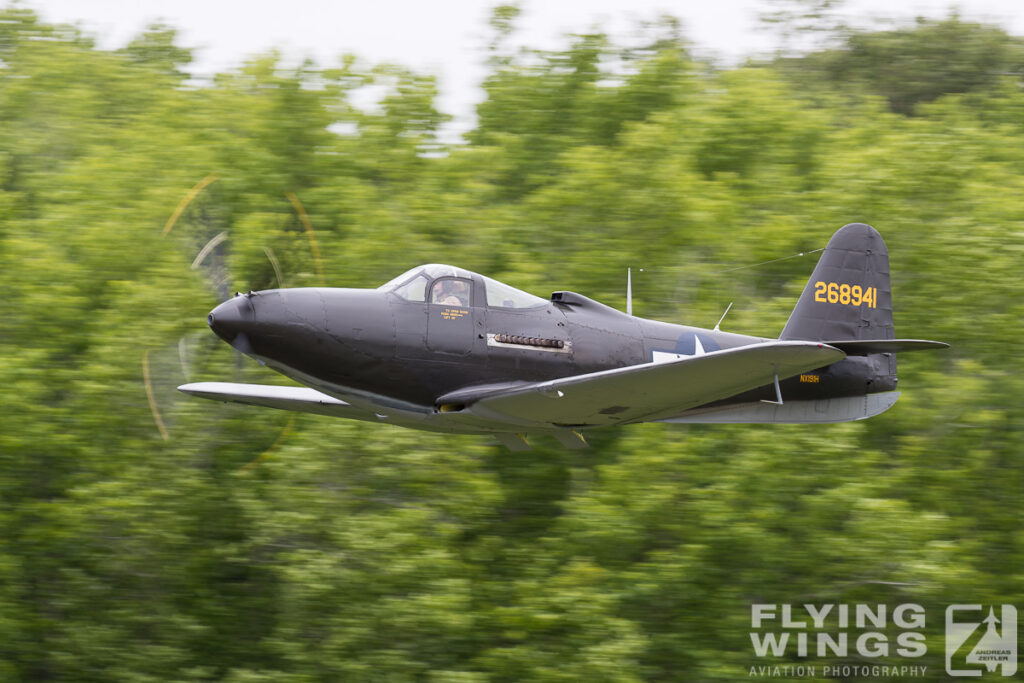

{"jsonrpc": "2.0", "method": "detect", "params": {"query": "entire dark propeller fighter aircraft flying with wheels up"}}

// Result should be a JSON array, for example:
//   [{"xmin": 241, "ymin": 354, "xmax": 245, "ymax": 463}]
[{"xmin": 179, "ymin": 223, "xmax": 947, "ymax": 449}]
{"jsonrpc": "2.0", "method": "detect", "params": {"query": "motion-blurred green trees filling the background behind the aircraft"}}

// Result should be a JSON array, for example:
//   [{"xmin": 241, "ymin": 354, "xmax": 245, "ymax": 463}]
[{"xmin": 0, "ymin": 5, "xmax": 1024, "ymax": 683}]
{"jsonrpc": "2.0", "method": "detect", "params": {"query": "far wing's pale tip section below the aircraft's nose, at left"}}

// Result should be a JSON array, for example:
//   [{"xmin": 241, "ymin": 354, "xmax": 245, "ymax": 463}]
[{"xmin": 178, "ymin": 382, "xmax": 376, "ymax": 421}]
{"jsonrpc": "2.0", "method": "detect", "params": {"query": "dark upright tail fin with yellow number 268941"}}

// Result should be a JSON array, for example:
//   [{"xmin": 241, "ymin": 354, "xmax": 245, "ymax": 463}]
[{"xmin": 779, "ymin": 223, "xmax": 896, "ymax": 341}]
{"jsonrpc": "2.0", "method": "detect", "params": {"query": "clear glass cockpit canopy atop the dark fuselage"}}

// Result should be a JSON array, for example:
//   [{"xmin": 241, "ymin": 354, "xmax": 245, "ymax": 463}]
[{"xmin": 377, "ymin": 263, "xmax": 548, "ymax": 308}]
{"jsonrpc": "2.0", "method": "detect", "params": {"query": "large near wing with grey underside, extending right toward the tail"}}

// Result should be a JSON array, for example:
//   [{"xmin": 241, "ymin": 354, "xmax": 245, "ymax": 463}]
[{"xmin": 460, "ymin": 341, "xmax": 846, "ymax": 427}]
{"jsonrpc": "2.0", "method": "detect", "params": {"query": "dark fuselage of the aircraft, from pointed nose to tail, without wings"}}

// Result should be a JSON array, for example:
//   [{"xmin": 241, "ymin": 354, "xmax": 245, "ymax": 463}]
[{"xmin": 203, "ymin": 283, "xmax": 896, "ymax": 411}]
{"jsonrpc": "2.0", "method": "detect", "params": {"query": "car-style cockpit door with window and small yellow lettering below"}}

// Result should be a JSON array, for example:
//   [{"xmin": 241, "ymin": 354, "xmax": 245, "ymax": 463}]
[{"xmin": 427, "ymin": 278, "xmax": 482, "ymax": 356}]
